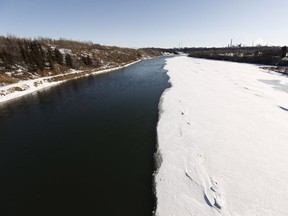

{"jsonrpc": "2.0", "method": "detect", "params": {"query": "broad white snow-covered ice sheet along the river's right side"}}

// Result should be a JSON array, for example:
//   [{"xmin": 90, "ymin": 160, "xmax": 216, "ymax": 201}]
[{"xmin": 155, "ymin": 56, "xmax": 288, "ymax": 216}]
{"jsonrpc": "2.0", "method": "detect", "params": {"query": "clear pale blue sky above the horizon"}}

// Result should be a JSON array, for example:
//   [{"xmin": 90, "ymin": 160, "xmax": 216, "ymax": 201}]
[{"xmin": 0, "ymin": 0, "xmax": 288, "ymax": 47}]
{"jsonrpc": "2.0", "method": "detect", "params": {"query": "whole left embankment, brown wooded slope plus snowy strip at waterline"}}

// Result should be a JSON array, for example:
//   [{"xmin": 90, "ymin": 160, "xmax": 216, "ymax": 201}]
[{"xmin": 0, "ymin": 37, "xmax": 173, "ymax": 102}]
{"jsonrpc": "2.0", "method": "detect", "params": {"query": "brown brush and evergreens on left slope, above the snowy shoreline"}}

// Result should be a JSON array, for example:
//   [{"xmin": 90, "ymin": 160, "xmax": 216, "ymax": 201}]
[{"xmin": 0, "ymin": 36, "xmax": 171, "ymax": 84}]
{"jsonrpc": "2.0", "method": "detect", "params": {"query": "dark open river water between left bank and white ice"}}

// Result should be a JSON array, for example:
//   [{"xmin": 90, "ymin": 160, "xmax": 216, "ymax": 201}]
[{"xmin": 0, "ymin": 58, "xmax": 170, "ymax": 216}]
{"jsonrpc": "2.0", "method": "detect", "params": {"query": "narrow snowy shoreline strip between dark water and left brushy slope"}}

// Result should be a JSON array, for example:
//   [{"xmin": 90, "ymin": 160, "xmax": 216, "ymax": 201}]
[{"xmin": 0, "ymin": 60, "xmax": 141, "ymax": 103}]
